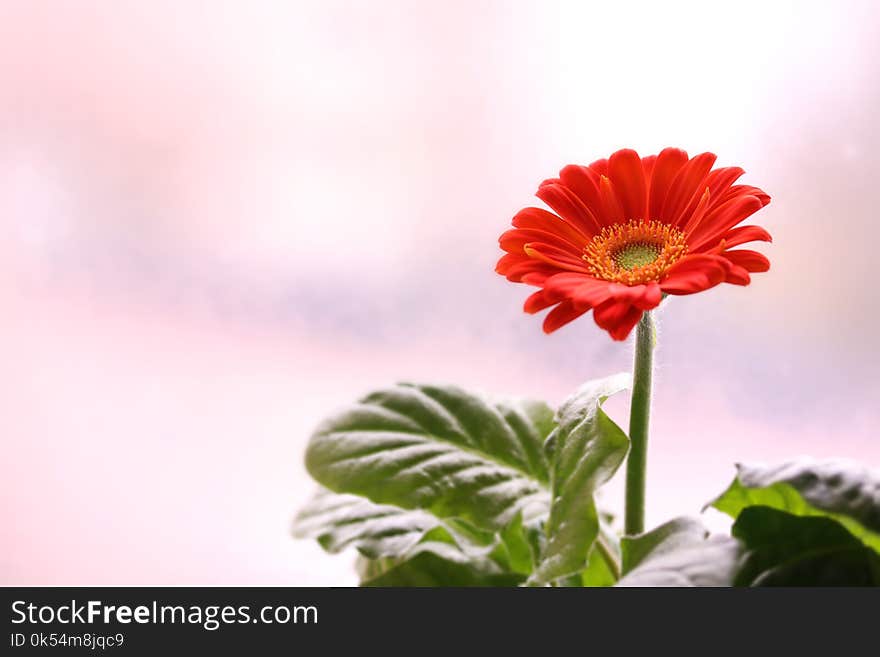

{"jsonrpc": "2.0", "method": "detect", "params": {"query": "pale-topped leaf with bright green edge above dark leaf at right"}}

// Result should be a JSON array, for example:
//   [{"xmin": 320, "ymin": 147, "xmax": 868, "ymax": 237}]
[{"xmin": 711, "ymin": 459, "xmax": 880, "ymax": 551}]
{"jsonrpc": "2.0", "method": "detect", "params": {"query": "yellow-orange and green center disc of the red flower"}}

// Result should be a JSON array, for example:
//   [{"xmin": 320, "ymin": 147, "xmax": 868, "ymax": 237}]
[{"xmin": 583, "ymin": 219, "xmax": 687, "ymax": 285}]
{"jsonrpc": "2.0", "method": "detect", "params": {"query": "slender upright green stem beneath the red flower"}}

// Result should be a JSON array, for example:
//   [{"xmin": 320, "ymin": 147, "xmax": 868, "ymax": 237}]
[{"xmin": 624, "ymin": 312, "xmax": 655, "ymax": 535}]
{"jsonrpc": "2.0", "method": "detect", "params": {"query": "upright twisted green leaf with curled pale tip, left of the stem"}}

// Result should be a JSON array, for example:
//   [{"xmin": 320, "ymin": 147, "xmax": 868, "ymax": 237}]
[{"xmin": 529, "ymin": 375, "xmax": 629, "ymax": 586}]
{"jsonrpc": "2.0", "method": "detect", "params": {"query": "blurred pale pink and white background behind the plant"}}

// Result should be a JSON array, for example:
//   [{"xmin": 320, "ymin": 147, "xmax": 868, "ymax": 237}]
[{"xmin": 0, "ymin": 0, "xmax": 880, "ymax": 585}]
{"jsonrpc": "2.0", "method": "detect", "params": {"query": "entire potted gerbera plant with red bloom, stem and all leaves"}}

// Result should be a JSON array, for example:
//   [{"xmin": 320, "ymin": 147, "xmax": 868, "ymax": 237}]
[{"xmin": 295, "ymin": 148, "xmax": 880, "ymax": 586}]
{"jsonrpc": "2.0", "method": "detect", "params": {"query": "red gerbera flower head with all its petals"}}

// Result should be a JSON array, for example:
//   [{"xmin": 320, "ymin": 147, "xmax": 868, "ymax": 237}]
[{"xmin": 496, "ymin": 148, "xmax": 771, "ymax": 340}]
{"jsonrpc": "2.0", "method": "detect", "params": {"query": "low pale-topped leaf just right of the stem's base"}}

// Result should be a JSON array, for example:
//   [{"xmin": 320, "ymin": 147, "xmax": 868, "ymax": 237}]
[{"xmin": 617, "ymin": 518, "xmax": 742, "ymax": 586}]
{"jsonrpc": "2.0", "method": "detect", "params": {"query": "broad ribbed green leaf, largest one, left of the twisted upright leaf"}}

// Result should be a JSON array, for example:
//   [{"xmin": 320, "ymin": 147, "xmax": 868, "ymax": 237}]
[{"xmin": 306, "ymin": 384, "xmax": 553, "ymax": 531}]
